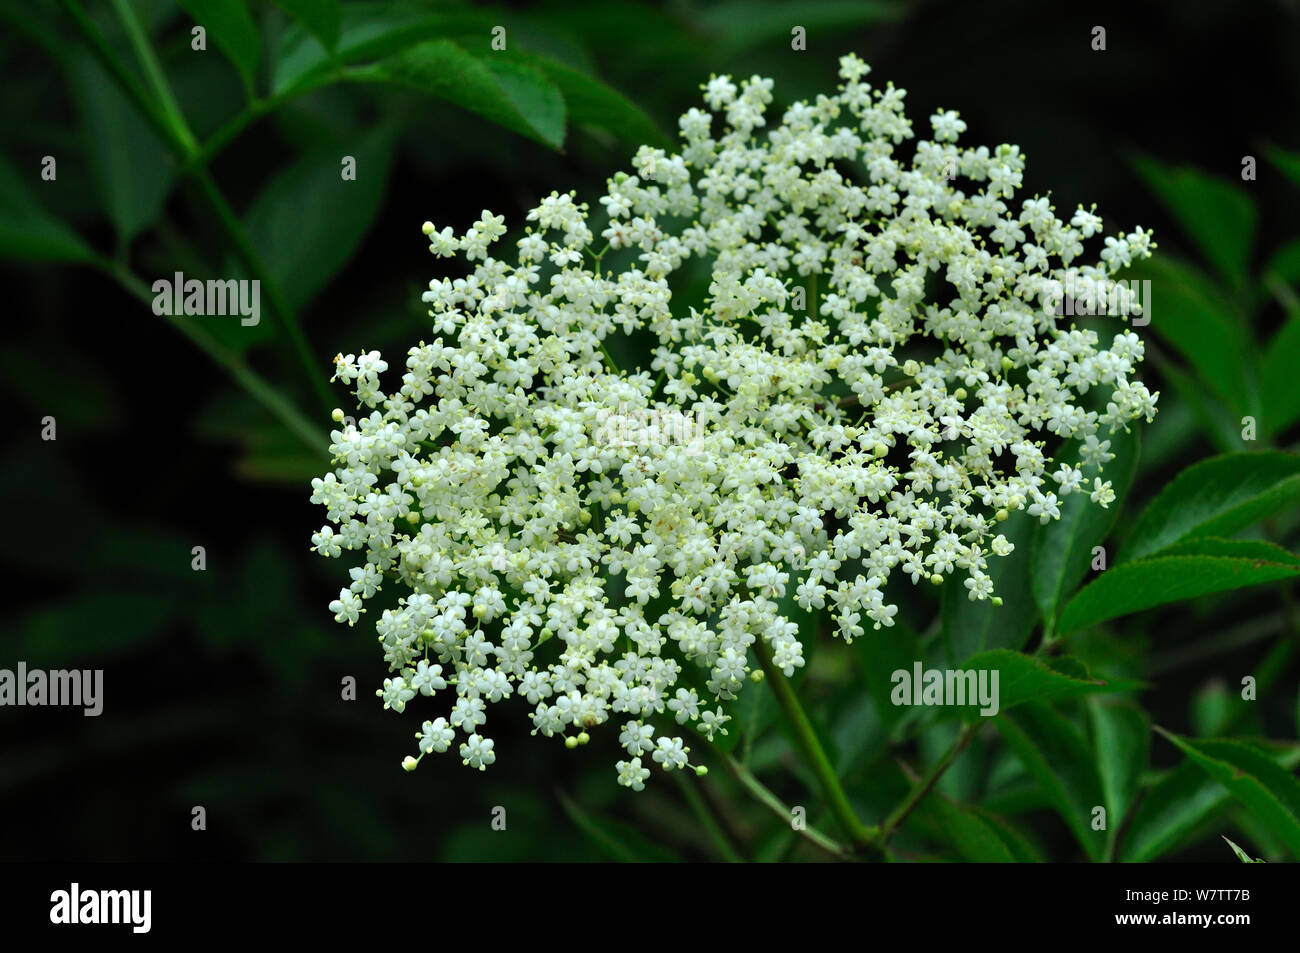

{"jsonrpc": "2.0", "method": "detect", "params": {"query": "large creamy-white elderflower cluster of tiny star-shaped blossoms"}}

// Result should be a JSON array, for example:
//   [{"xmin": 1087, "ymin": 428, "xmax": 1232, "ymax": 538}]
[{"xmin": 312, "ymin": 56, "xmax": 1156, "ymax": 790}]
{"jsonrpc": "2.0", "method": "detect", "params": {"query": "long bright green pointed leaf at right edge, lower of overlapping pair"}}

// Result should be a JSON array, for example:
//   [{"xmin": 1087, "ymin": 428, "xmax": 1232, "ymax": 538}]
[{"xmin": 1061, "ymin": 555, "xmax": 1300, "ymax": 633}]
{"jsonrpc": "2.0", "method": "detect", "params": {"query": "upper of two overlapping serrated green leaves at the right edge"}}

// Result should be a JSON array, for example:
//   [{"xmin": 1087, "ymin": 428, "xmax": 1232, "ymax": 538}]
[{"xmin": 1119, "ymin": 451, "xmax": 1300, "ymax": 562}]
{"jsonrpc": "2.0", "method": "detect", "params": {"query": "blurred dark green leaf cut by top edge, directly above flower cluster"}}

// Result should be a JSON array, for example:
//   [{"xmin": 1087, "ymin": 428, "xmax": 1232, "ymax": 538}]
[{"xmin": 689, "ymin": 0, "xmax": 906, "ymax": 53}]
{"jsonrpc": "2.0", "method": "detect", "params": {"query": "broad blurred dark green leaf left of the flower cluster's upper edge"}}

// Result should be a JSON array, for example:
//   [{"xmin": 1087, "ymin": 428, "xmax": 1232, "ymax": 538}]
[{"xmin": 246, "ymin": 130, "xmax": 393, "ymax": 308}]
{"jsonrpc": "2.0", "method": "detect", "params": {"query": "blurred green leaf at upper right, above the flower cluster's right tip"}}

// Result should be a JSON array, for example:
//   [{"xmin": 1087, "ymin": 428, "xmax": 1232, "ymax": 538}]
[{"xmin": 1134, "ymin": 156, "xmax": 1258, "ymax": 287}]
